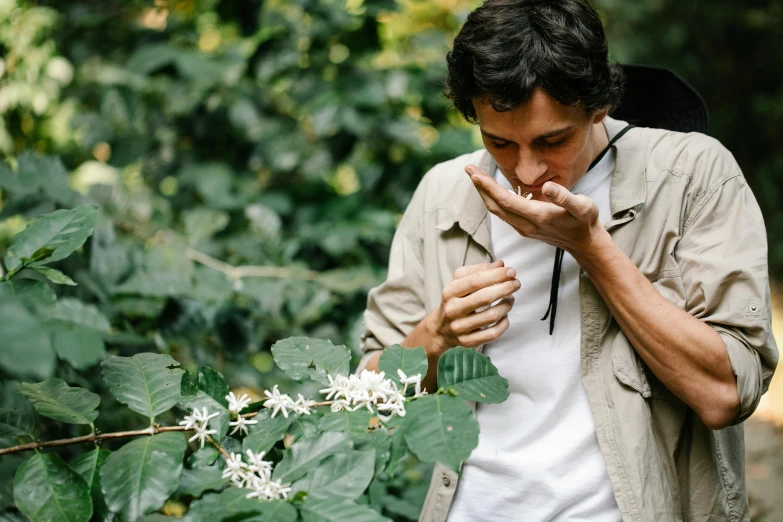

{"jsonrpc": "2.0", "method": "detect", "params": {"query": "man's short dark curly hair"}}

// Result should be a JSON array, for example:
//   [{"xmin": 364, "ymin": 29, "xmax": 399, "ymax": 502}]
[{"xmin": 445, "ymin": 0, "xmax": 624, "ymax": 123}]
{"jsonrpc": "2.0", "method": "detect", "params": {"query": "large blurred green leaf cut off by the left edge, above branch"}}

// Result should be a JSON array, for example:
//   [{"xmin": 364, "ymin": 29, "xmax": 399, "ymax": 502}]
[{"xmin": 0, "ymin": 294, "xmax": 56, "ymax": 379}]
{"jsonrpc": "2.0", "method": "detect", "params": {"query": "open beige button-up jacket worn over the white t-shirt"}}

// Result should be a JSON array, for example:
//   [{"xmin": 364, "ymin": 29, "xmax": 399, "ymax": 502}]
[{"xmin": 362, "ymin": 118, "xmax": 778, "ymax": 522}]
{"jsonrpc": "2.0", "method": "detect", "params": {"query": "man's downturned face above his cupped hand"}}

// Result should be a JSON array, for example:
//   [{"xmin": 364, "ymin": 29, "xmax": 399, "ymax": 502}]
[{"xmin": 473, "ymin": 89, "xmax": 607, "ymax": 200}]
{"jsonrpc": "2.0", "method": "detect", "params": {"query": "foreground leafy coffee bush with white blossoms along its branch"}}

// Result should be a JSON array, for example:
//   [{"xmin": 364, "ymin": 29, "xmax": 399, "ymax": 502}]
[{"xmin": 0, "ymin": 205, "xmax": 508, "ymax": 521}]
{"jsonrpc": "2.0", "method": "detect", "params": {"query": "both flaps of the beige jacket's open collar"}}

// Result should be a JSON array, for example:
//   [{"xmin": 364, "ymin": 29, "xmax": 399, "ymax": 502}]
[{"xmin": 450, "ymin": 116, "xmax": 647, "ymax": 244}]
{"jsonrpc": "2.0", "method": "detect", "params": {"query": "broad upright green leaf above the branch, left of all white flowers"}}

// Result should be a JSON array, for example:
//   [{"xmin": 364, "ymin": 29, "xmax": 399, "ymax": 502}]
[{"xmin": 101, "ymin": 353, "xmax": 182, "ymax": 423}]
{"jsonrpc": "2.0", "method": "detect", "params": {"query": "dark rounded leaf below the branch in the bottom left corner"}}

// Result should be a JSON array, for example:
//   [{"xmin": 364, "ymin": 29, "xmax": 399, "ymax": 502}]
[{"xmin": 14, "ymin": 453, "xmax": 92, "ymax": 522}]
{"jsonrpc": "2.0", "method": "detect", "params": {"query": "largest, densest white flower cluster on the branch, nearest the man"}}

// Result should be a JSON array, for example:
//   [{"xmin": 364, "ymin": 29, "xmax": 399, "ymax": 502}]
[{"xmin": 321, "ymin": 370, "xmax": 427, "ymax": 422}]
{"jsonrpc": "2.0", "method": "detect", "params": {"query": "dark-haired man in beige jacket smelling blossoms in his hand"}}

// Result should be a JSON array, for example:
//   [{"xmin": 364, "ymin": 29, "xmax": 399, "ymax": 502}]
[{"xmin": 362, "ymin": 0, "xmax": 778, "ymax": 522}]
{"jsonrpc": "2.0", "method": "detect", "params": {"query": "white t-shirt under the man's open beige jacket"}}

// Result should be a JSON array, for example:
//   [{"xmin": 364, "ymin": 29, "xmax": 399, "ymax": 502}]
[{"xmin": 448, "ymin": 148, "xmax": 622, "ymax": 522}]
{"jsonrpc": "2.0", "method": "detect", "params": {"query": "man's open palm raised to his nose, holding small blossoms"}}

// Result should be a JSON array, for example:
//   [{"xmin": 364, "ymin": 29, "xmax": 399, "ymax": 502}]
[{"xmin": 465, "ymin": 160, "xmax": 606, "ymax": 255}]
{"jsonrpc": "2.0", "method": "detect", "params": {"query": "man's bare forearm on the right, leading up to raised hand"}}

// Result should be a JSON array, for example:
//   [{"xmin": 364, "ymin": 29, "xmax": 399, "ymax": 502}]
[{"xmin": 573, "ymin": 231, "xmax": 739, "ymax": 429}]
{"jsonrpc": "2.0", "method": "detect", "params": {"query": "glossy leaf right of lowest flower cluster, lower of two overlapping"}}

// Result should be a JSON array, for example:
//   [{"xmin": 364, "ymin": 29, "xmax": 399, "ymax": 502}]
[{"xmin": 292, "ymin": 449, "xmax": 375, "ymax": 501}]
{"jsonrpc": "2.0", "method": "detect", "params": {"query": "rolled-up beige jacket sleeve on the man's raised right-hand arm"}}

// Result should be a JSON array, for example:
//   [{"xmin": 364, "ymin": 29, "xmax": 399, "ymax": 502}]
[{"xmin": 675, "ymin": 170, "xmax": 778, "ymax": 424}]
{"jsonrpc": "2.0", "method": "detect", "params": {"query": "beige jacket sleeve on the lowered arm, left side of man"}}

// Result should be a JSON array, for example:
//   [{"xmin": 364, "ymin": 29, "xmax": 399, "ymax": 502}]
[{"xmin": 356, "ymin": 181, "xmax": 426, "ymax": 372}]
